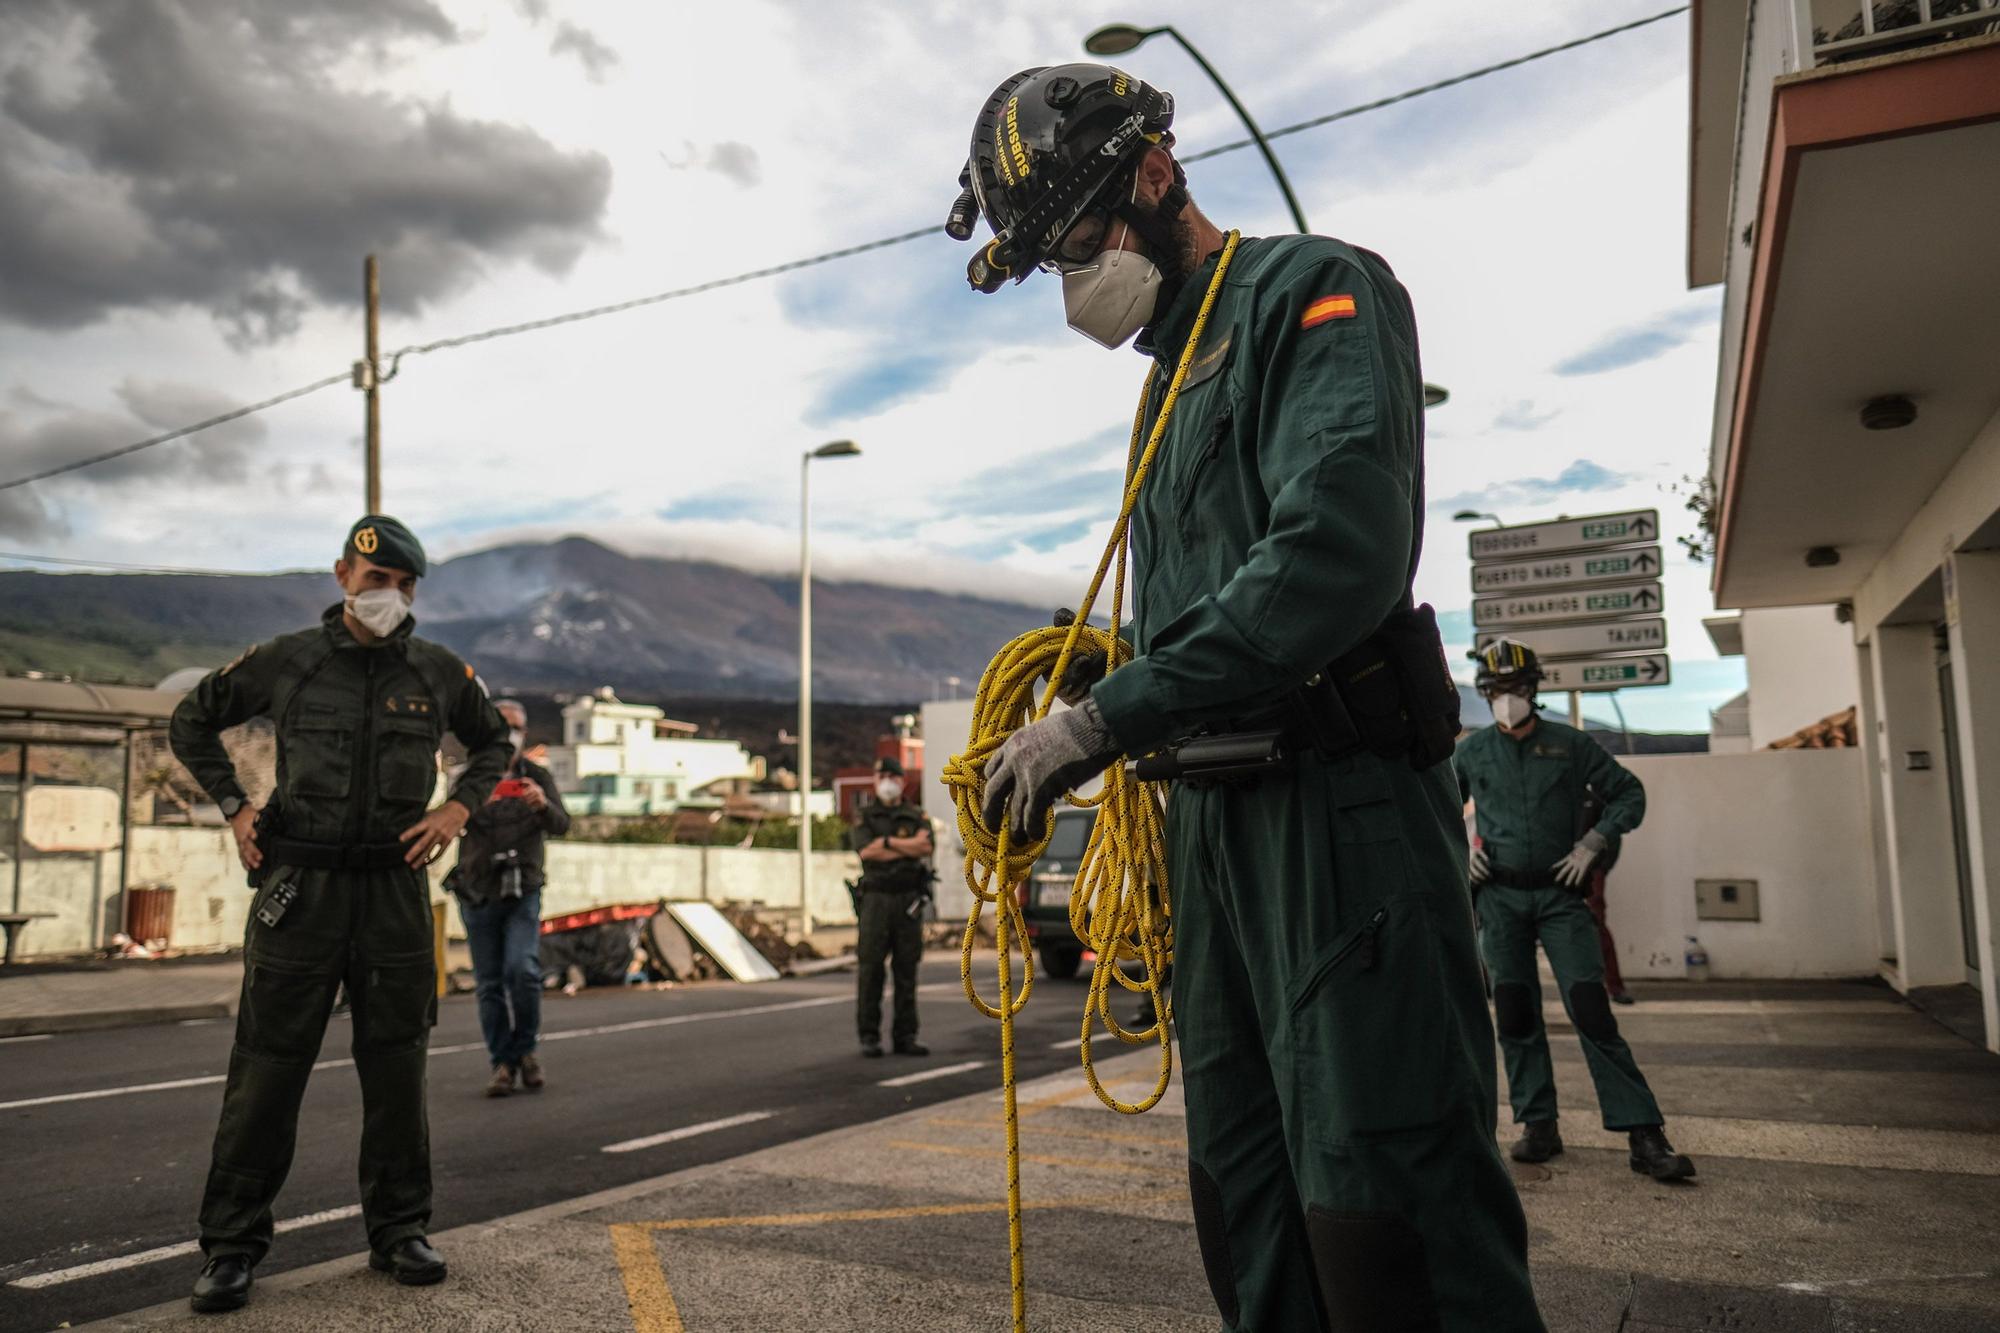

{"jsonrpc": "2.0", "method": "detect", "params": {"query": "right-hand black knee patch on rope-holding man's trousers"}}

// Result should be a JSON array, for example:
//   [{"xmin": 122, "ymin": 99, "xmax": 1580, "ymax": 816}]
[{"xmin": 1306, "ymin": 1205, "xmax": 1444, "ymax": 1333}]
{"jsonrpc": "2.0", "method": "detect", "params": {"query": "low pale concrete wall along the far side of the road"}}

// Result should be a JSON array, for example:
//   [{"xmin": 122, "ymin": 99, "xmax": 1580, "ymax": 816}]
[{"xmin": 52, "ymin": 827, "xmax": 860, "ymax": 957}]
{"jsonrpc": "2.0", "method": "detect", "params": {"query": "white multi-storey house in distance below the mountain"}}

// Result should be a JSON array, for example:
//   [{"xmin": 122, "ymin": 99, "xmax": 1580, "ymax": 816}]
[{"xmin": 548, "ymin": 685, "xmax": 764, "ymax": 815}]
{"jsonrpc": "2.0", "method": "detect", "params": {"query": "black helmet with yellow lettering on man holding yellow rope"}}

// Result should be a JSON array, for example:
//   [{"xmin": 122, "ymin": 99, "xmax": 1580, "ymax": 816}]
[{"xmin": 944, "ymin": 64, "xmax": 1188, "ymax": 292}]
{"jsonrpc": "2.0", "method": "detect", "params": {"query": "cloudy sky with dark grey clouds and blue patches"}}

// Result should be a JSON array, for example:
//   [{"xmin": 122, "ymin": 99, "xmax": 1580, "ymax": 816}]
[{"xmin": 0, "ymin": 0, "xmax": 1742, "ymax": 729}]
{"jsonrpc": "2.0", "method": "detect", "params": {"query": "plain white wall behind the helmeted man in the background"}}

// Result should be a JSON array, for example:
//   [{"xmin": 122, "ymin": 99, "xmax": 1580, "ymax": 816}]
[{"xmin": 1608, "ymin": 751, "xmax": 1878, "ymax": 977}]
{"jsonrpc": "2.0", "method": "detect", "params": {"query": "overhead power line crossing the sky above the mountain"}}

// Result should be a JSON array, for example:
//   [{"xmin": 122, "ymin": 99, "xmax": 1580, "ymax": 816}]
[{"xmin": 0, "ymin": 4, "xmax": 1688, "ymax": 490}]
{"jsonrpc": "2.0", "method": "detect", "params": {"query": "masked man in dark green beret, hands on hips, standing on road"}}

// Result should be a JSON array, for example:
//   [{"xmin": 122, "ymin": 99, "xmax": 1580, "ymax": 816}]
[{"xmin": 170, "ymin": 514, "xmax": 512, "ymax": 1311}]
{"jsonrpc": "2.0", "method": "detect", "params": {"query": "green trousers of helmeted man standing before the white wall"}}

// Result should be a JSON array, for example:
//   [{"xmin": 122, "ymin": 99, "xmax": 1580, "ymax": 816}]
[{"xmin": 1478, "ymin": 885, "xmax": 1660, "ymax": 1129}]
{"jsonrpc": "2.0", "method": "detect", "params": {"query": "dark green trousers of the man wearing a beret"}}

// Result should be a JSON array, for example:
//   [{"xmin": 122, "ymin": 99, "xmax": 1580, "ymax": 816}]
[{"xmin": 200, "ymin": 867, "xmax": 438, "ymax": 1261}]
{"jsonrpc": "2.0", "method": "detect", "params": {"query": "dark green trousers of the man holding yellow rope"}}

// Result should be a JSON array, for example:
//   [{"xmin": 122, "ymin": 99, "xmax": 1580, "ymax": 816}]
[{"xmin": 1168, "ymin": 755, "xmax": 1544, "ymax": 1333}]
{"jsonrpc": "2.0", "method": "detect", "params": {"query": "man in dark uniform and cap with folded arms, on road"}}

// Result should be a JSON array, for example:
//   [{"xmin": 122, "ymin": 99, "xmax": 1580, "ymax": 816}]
[{"xmin": 848, "ymin": 759, "xmax": 936, "ymax": 1057}]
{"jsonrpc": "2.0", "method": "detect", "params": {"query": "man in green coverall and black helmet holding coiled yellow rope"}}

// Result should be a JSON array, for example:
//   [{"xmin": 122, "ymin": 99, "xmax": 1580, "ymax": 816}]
[{"xmin": 946, "ymin": 64, "xmax": 1544, "ymax": 1333}]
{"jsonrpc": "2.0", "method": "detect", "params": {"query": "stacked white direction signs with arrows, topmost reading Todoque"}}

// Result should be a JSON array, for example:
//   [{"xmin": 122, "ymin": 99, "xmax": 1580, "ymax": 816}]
[{"xmin": 1470, "ymin": 508, "xmax": 1674, "ymax": 727}]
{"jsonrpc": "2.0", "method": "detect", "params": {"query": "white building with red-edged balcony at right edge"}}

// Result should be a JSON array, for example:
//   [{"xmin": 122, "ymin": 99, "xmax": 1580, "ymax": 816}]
[{"xmin": 1688, "ymin": 0, "xmax": 2000, "ymax": 1051}]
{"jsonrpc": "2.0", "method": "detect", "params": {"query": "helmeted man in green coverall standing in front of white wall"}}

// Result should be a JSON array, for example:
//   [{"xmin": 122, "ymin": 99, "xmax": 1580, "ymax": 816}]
[{"xmin": 1454, "ymin": 638, "xmax": 1694, "ymax": 1181}]
